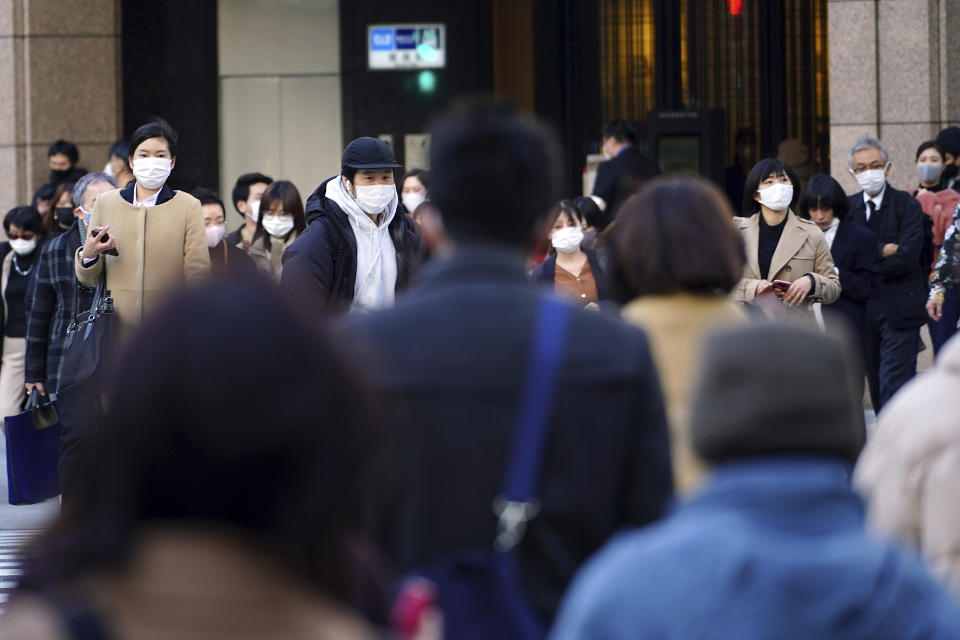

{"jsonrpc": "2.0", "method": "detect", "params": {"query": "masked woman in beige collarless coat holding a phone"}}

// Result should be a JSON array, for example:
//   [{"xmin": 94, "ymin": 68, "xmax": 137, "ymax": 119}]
[{"xmin": 76, "ymin": 119, "xmax": 210, "ymax": 332}]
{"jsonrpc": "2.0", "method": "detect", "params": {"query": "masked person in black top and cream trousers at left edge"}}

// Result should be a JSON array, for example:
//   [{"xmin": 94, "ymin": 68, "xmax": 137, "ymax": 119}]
[{"xmin": 0, "ymin": 207, "xmax": 47, "ymax": 418}]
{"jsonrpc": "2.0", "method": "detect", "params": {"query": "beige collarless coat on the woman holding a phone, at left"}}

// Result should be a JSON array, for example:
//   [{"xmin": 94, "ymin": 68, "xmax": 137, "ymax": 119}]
[{"xmin": 75, "ymin": 190, "xmax": 210, "ymax": 330}]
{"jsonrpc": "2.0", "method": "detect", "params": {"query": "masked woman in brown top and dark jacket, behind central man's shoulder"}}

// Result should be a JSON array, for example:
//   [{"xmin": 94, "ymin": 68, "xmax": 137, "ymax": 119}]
[{"xmin": 533, "ymin": 200, "xmax": 608, "ymax": 310}]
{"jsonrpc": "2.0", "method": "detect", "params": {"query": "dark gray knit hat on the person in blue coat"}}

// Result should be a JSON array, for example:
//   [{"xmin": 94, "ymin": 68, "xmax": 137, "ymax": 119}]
[{"xmin": 691, "ymin": 323, "xmax": 865, "ymax": 463}]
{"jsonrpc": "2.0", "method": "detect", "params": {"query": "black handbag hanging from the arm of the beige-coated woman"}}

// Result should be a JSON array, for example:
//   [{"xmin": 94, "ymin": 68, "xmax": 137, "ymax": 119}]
[{"xmin": 57, "ymin": 256, "xmax": 116, "ymax": 398}]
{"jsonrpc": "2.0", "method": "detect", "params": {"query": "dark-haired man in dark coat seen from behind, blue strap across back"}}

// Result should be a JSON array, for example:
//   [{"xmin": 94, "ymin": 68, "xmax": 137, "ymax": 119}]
[{"xmin": 348, "ymin": 105, "xmax": 672, "ymax": 623}]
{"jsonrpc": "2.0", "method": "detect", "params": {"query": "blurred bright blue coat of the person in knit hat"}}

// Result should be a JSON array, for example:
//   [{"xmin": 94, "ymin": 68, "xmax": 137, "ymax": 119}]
[{"xmin": 551, "ymin": 457, "xmax": 960, "ymax": 640}]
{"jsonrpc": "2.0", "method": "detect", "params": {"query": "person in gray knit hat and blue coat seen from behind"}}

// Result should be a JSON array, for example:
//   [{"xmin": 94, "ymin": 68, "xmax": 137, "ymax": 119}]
[{"xmin": 551, "ymin": 324, "xmax": 960, "ymax": 640}]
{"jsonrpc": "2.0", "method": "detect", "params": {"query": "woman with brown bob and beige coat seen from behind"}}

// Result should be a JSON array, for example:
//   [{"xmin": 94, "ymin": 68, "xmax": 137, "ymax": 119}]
[{"xmin": 610, "ymin": 178, "xmax": 747, "ymax": 493}]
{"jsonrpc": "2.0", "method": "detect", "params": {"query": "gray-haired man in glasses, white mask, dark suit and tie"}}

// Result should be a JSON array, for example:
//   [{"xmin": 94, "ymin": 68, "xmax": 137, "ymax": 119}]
[{"xmin": 847, "ymin": 136, "xmax": 927, "ymax": 411}]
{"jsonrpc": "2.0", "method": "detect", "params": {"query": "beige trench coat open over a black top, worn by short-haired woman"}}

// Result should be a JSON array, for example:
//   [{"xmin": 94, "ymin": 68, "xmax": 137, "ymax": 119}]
[{"xmin": 733, "ymin": 211, "xmax": 840, "ymax": 317}]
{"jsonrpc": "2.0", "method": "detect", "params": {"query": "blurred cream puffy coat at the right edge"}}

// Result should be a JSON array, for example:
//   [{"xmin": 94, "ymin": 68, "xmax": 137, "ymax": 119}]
[{"xmin": 854, "ymin": 338, "xmax": 960, "ymax": 598}]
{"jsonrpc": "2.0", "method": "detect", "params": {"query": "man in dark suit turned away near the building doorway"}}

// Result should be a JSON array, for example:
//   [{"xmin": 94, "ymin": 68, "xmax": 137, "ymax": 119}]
[{"xmin": 593, "ymin": 120, "xmax": 660, "ymax": 222}]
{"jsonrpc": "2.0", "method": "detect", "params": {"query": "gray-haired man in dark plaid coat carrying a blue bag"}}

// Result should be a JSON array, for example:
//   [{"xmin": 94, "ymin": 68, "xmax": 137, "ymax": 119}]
[{"xmin": 25, "ymin": 173, "xmax": 117, "ymax": 504}]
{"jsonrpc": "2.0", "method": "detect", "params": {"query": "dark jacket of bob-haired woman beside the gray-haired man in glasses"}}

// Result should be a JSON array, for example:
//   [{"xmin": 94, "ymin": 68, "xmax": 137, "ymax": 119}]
[{"xmin": 826, "ymin": 221, "xmax": 881, "ymax": 334}]
